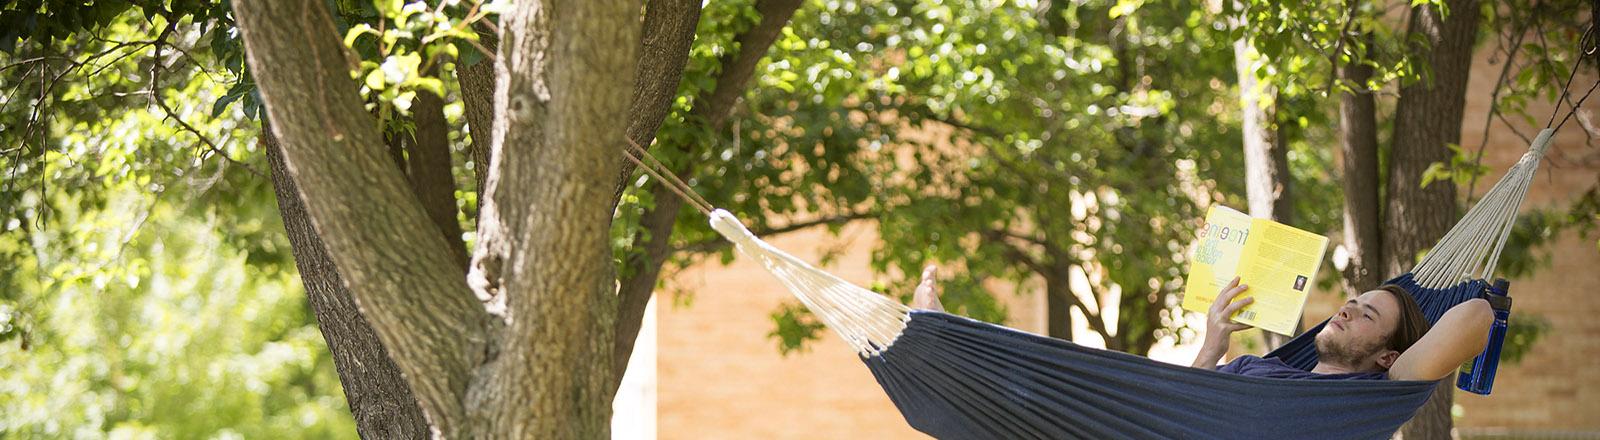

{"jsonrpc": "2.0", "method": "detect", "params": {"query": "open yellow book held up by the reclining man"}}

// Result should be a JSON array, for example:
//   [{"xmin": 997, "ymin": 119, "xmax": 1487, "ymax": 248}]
[{"xmin": 1182, "ymin": 205, "xmax": 1328, "ymax": 334}]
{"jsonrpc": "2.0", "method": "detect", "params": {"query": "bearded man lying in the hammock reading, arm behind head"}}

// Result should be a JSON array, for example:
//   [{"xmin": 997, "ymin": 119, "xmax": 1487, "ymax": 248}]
[{"xmin": 912, "ymin": 267, "xmax": 1494, "ymax": 381}]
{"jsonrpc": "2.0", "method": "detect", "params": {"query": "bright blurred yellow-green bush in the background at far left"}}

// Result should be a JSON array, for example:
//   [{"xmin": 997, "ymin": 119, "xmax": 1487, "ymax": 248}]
[{"xmin": 0, "ymin": 81, "xmax": 354, "ymax": 438}]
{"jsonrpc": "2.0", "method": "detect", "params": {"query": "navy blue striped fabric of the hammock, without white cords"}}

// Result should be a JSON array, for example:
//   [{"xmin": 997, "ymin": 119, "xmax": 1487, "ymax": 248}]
[{"xmin": 862, "ymin": 275, "xmax": 1483, "ymax": 438}]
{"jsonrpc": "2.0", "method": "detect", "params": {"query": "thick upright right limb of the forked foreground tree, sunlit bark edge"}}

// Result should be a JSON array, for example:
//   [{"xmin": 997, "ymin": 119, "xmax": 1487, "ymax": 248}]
[{"xmin": 466, "ymin": 0, "xmax": 640, "ymax": 438}]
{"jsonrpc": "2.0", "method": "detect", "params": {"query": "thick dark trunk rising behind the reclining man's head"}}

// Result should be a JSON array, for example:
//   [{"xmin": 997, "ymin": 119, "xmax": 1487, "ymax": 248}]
[{"xmin": 1382, "ymin": 0, "xmax": 1480, "ymax": 438}]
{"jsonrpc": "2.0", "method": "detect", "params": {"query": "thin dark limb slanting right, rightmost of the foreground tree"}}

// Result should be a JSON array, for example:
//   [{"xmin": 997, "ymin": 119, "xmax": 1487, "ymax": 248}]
[{"xmin": 611, "ymin": 0, "xmax": 800, "ymax": 378}]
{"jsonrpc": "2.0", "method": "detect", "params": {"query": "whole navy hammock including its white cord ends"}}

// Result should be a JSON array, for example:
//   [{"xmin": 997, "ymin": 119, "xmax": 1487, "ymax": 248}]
[{"xmin": 684, "ymin": 130, "xmax": 1554, "ymax": 438}]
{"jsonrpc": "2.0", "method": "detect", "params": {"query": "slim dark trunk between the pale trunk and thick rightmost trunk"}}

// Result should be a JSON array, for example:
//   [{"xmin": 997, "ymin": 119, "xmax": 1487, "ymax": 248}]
[{"xmin": 1339, "ymin": 35, "xmax": 1386, "ymax": 293}]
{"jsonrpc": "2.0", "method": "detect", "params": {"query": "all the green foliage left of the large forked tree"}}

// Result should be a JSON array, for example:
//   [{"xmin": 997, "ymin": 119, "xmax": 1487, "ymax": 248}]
[{"xmin": 0, "ymin": 6, "xmax": 355, "ymax": 438}]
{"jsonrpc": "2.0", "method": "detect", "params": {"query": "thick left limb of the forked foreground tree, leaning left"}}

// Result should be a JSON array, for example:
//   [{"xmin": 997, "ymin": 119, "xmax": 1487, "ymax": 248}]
[{"xmin": 234, "ymin": 0, "xmax": 486, "ymax": 437}]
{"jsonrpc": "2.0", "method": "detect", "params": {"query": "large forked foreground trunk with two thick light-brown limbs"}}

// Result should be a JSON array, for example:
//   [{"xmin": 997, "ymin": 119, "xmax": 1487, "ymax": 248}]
[{"xmin": 235, "ymin": 0, "xmax": 700, "ymax": 438}]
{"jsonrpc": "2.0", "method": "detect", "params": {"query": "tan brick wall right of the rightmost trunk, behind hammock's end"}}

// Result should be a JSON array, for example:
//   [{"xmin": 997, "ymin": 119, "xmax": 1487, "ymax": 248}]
[{"xmin": 1456, "ymin": 51, "xmax": 1600, "ymax": 438}]
